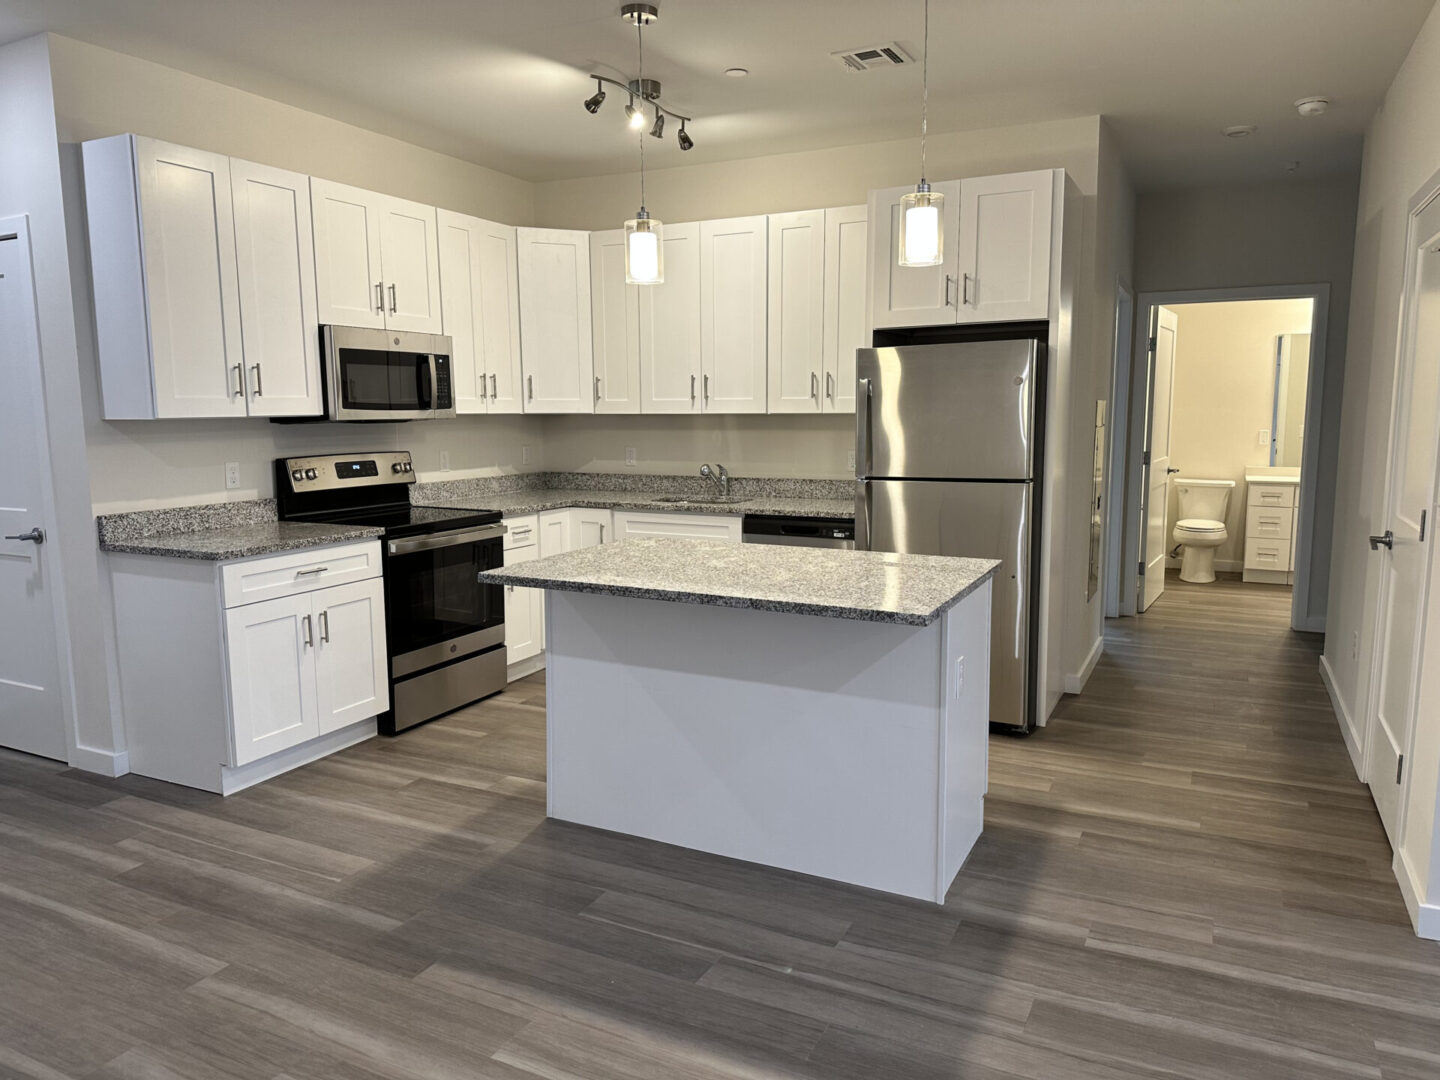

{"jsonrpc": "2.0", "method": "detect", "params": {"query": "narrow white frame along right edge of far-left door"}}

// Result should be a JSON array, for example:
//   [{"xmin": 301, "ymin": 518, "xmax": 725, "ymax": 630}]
[{"xmin": 0, "ymin": 213, "xmax": 75, "ymax": 765}]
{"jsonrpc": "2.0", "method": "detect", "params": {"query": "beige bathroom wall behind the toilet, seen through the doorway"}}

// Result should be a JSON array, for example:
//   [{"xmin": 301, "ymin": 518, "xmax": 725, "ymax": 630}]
[{"xmin": 1165, "ymin": 300, "xmax": 1313, "ymax": 570}]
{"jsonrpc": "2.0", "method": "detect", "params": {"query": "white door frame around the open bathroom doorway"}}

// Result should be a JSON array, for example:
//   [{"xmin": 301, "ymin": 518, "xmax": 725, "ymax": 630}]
[{"xmin": 1119, "ymin": 282, "xmax": 1331, "ymax": 634}]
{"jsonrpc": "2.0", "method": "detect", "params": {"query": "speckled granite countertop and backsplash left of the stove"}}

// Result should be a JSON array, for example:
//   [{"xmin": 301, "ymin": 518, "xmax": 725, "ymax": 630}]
[{"xmin": 95, "ymin": 498, "xmax": 382, "ymax": 562}]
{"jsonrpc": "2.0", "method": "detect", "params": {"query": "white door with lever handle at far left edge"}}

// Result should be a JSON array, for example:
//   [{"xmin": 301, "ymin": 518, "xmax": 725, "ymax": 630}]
[{"xmin": 0, "ymin": 219, "xmax": 66, "ymax": 760}]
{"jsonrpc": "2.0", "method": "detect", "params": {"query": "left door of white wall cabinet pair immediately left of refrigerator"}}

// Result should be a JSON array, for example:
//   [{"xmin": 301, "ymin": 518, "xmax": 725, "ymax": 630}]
[{"xmin": 769, "ymin": 210, "xmax": 825, "ymax": 413}]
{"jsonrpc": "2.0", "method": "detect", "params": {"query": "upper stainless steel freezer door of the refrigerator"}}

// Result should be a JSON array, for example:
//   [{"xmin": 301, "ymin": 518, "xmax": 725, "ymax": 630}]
[{"xmin": 855, "ymin": 338, "xmax": 1038, "ymax": 480}]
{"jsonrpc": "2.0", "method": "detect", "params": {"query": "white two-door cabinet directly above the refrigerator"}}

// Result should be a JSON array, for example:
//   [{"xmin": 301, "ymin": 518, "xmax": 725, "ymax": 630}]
[{"xmin": 870, "ymin": 168, "xmax": 1063, "ymax": 328}]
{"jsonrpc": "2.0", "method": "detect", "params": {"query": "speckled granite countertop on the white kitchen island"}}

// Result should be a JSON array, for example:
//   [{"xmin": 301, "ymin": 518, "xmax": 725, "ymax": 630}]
[{"xmin": 480, "ymin": 537, "xmax": 999, "ymax": 626}]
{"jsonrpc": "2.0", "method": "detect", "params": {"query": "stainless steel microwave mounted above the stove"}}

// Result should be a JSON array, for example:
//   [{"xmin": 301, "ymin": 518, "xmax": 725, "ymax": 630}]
[{"xmin": 321, "ymin": 325, "xmax": 455, "ymax": 420}]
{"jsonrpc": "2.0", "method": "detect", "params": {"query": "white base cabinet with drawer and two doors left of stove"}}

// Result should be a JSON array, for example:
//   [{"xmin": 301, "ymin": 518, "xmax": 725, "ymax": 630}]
[{"xmin": 108, "ymin": 541, "xmax": 390, "ymax": 795}]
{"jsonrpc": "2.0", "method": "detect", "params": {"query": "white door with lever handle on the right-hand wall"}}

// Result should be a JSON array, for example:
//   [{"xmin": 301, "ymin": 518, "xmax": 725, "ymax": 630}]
[{"xmin": 1367, "ymin": 199, "xmax": 1440, "ymax": 845}]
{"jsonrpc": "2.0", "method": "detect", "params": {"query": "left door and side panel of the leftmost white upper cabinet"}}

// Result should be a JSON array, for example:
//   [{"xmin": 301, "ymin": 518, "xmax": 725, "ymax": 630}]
[{"xmin": 82, "ymin": 135, "xmax": 246, "ymax": 419}]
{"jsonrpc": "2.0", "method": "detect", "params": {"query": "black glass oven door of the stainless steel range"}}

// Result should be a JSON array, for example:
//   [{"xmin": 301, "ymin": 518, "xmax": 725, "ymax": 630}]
[{"xmin": 384, "ymin": 523, "xmax": 505, "ymax": 678}]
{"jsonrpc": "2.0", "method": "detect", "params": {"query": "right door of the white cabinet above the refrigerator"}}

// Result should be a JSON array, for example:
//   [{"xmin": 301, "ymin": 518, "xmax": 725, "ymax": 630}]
[{"xmin": 956, "ymin": 168, "xmax": 1056, "ymax": 323}]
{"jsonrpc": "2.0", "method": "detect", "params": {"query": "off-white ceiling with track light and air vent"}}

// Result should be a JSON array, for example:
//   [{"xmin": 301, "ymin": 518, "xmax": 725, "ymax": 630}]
[{"xmin": 0, "ymin": 0, "xmax": 1434, "ymax": 189}]
